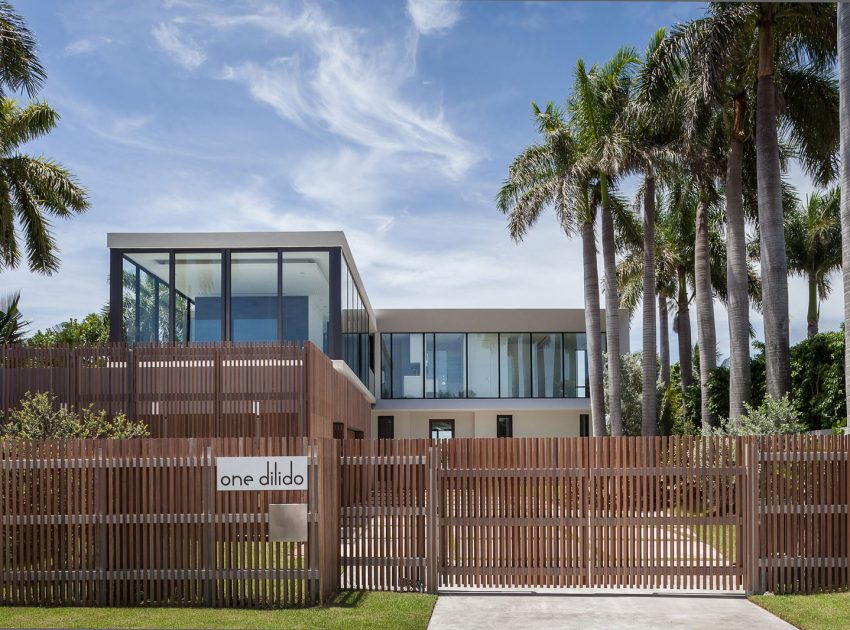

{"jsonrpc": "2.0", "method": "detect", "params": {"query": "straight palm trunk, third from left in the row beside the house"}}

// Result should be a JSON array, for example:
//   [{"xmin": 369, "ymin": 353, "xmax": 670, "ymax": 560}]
[{"xmin": 641, "ymin": 173, "xmax": 658, "ymax": 435}]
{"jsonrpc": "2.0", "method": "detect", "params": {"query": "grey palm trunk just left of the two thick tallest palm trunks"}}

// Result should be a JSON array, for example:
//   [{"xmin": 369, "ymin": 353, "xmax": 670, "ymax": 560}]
[{"xmin": 694, "ymin": 195, "xmax": 717, "ymax": 435}]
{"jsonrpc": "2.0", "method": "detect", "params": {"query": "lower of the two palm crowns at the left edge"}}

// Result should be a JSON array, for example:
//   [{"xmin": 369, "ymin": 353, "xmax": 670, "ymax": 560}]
[{"xmin": 0, "ymin": 98, "xmax": 88, "ymax": 274}]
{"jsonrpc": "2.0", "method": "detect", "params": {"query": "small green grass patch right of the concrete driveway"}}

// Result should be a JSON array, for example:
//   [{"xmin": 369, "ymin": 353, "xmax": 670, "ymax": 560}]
[{"xmin": 750, "ymin": 592, "xmax": 850, "ymax": 630}]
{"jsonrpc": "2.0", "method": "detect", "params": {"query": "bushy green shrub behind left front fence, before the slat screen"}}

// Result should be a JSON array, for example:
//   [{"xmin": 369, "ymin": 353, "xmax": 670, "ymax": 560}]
[{"xmin": 0, "ymin": 392, "xmax": 150, "ymax": 440}]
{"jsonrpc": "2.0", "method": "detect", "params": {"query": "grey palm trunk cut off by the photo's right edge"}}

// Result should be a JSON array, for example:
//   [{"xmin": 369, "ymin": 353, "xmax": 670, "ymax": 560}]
[{"xmin": 838, "ymin": 2, "xmax": 850, "ymax": 417}]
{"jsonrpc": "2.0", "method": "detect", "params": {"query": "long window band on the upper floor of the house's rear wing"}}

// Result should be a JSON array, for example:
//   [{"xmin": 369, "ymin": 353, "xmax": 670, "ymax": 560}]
[{"xmin": 381, "ymin": 333, "xmax": 592, "ymax": 399}]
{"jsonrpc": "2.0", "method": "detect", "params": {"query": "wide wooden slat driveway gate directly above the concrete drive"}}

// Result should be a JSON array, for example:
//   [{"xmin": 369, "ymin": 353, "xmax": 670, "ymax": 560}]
[{"xmin": 439, "ymin": 438, "xmax": 745, "ymax": 591}]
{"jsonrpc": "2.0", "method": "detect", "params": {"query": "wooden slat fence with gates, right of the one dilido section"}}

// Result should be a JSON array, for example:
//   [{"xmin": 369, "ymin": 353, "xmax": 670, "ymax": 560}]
[{"xmin": 341, "ymin": 436, "xmax": 850, "ymax": 592}]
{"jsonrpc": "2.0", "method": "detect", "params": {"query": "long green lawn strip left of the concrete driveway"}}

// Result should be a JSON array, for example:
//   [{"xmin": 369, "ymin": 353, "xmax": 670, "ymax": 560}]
[{"xmin": 0, "ymin": 591, "xmax": 437, "ymax": 630}]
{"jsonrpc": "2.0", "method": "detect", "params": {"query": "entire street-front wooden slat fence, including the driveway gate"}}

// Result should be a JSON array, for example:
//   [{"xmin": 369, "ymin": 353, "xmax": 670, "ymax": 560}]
[{"xmin": 0, "ymin": 436, "xmax": 850, "ymax": 607}]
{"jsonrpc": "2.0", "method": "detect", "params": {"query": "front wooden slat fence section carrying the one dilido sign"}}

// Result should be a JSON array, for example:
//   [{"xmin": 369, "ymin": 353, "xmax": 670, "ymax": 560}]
[{"xmin": 0, "ymin": 438, "xmax": 339, "ymax": 608}]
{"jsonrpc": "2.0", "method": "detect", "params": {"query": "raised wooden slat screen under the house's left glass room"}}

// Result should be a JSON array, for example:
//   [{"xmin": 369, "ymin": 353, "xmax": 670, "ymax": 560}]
[{"xmin": 0, "ymin": 342, "xmax": 371, "ymax": 438}]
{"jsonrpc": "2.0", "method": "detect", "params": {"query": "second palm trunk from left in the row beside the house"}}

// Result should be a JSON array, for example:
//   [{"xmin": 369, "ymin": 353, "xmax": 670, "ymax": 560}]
[{"xmin": 600, "ymin": 175, "xmax": 624, "ymax": 436}]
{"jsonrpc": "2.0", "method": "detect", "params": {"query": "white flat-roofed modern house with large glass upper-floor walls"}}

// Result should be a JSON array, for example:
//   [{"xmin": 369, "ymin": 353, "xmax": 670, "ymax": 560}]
[{"xmin": 107, "ymin": 232, "xmax": 628, "ymax": 438}]
